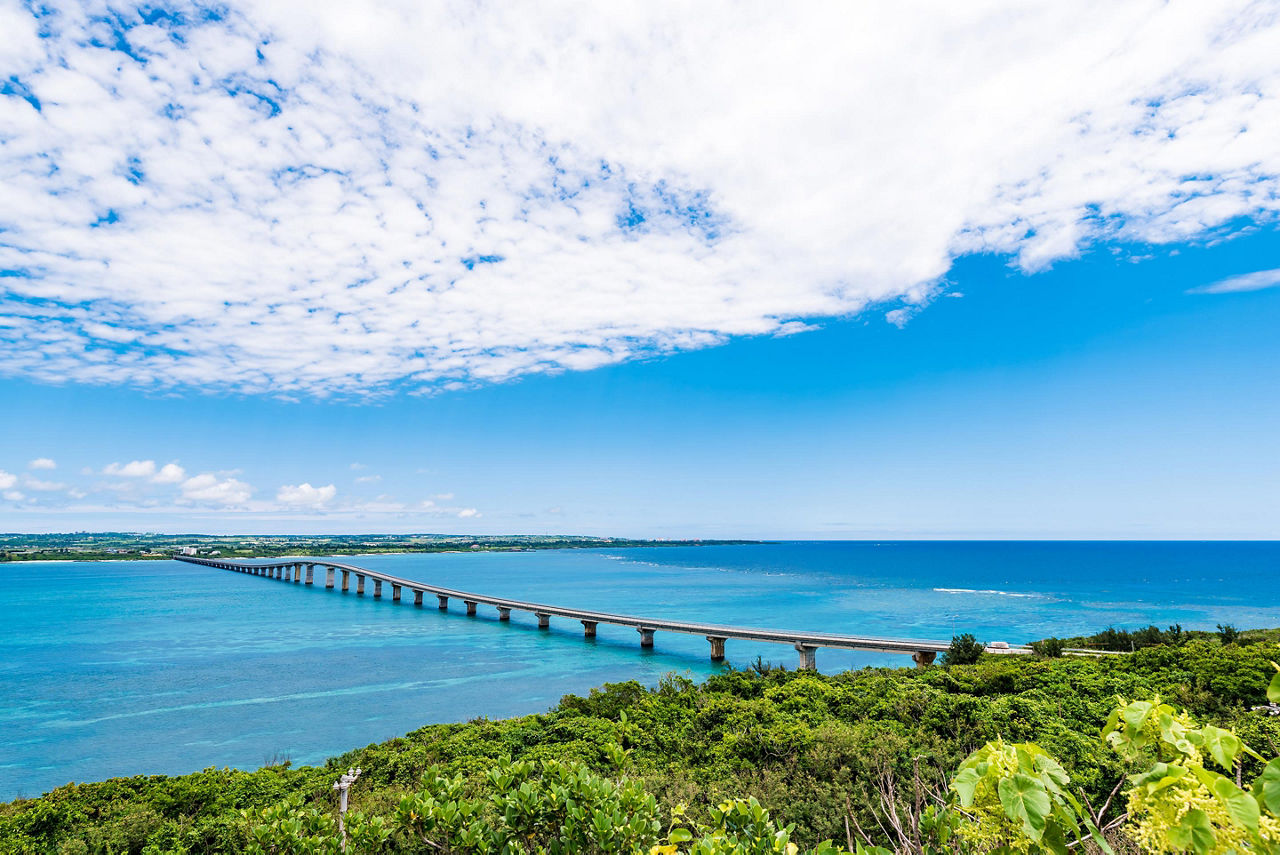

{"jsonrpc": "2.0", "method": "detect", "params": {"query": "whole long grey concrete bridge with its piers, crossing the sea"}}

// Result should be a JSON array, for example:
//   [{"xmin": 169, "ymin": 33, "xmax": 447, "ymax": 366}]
[{"xmin": 174, "ymin": 555, "xmax": 1030, "ymax": 669}]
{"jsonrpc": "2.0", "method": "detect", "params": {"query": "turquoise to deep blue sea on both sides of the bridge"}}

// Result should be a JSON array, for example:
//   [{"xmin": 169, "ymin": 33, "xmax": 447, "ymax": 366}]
[{"xmin": 0, "ymin": 543, "xmax": 1280, "ymax": 800}]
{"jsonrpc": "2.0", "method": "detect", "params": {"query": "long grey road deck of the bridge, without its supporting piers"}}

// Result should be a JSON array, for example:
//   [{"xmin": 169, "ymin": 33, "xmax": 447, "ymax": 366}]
[{"xmin": 174, "ymin": 555, "xmax": 1030, "ymax": 667}]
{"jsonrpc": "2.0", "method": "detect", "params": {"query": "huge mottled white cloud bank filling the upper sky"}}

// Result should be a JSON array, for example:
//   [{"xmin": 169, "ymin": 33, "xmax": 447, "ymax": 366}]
[{"xmin": 0, "ymin": 0, "xmax": 1280, "ymax": 396}]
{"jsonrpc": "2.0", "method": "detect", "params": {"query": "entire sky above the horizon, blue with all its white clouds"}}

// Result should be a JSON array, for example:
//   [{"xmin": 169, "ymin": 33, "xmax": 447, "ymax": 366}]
[{"xmin": 0, "ymin": 0, "xmax": 1280, "ymax": 538}]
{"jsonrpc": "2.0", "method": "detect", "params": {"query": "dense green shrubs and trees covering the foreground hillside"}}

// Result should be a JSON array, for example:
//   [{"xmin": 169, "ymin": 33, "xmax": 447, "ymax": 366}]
[{"xmin": 0, "ymin": 632, "xmax": 1280, "ymax": 855}]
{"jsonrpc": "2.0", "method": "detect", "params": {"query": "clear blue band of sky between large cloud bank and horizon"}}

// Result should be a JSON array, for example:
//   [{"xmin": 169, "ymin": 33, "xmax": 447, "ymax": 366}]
[{"xmin": 0, "ymin": 230, "xmax": 1280, "ymax": 538}]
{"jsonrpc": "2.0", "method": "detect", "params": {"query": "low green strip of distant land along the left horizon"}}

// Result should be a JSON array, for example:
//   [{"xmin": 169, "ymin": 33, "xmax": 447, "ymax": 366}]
[{"xmin": 0, "ymin": 531, "xmax": 759, "ymax": 563}]
